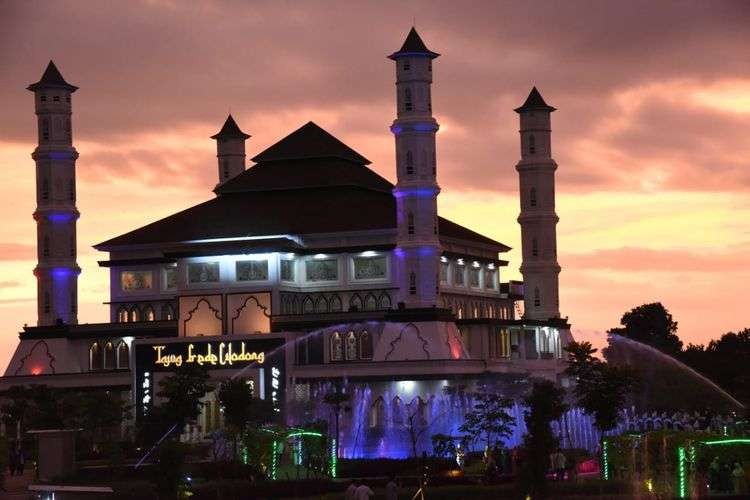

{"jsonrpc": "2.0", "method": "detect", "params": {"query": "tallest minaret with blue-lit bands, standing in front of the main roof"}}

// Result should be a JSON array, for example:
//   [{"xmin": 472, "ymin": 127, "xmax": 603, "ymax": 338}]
[{"xmin": 388, "ymin": 28, "xmax": 440, "ymax": 307}]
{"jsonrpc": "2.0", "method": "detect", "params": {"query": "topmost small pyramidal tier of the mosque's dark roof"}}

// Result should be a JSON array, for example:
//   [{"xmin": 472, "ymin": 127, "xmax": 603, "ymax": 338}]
[{"xmin": 252, "ymin": 122, "xmax": 370, "ymax": 165}]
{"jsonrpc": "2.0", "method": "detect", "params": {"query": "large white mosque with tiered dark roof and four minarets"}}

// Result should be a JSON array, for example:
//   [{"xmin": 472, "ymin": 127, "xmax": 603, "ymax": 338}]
[{"xmin": 0, "ymin": 28, "xmax": 572, "ymax": 456}]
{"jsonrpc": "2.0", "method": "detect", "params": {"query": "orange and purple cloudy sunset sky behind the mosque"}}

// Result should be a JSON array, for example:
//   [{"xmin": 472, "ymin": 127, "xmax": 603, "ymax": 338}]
[{"xmin": 0, "ymin": 0, "xmax": 750, "ymax": 372}]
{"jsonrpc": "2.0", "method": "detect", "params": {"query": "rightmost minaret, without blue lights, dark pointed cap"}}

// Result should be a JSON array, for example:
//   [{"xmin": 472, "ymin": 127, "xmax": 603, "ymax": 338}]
[{"xmin": 515, "ymin": 87, "xmax": 560, "ymax": 320}]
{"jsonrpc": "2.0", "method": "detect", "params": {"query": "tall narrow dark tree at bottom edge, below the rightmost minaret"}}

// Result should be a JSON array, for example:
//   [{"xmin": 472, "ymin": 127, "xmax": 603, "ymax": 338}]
[{"xmin": 521, "ymin": 380, "xmax": 567, "ymax": 498}]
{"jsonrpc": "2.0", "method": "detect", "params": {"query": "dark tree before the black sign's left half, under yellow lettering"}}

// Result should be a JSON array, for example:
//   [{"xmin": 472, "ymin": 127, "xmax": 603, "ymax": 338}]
[{"xmin": 157, "ymin": 364, "xmax": 211, "ymax": 432}]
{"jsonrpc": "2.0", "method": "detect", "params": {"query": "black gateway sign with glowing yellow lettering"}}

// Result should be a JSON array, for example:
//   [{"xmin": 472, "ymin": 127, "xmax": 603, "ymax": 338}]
[{"xmin": 131, "ymin": 335, "xmax": 286, "ymax": 418}]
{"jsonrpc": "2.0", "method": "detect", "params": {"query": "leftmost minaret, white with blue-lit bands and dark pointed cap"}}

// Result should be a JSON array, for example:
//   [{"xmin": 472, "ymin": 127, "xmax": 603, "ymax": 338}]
[{"xmin": 27, "ymin": 61, "xmax": 81, "ymax": 326}]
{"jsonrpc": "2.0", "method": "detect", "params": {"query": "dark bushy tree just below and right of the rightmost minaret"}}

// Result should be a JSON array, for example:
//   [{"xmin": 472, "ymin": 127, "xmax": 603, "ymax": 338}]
[{"xmin": 565, "ymin": 342, "xmax": 636, "ymax": 432}]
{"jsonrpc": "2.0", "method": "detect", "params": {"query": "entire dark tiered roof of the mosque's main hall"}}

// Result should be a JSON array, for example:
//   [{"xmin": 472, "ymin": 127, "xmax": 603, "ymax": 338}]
[{"xmin": 96, "ymin": 122, "xmax": 509, "ymax": 251}]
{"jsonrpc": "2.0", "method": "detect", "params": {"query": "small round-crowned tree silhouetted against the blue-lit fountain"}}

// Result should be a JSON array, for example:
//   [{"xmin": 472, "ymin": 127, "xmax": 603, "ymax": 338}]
[{"xmin": 458, "ymin": 392, "xmax": 513, "ymax": 449}]
